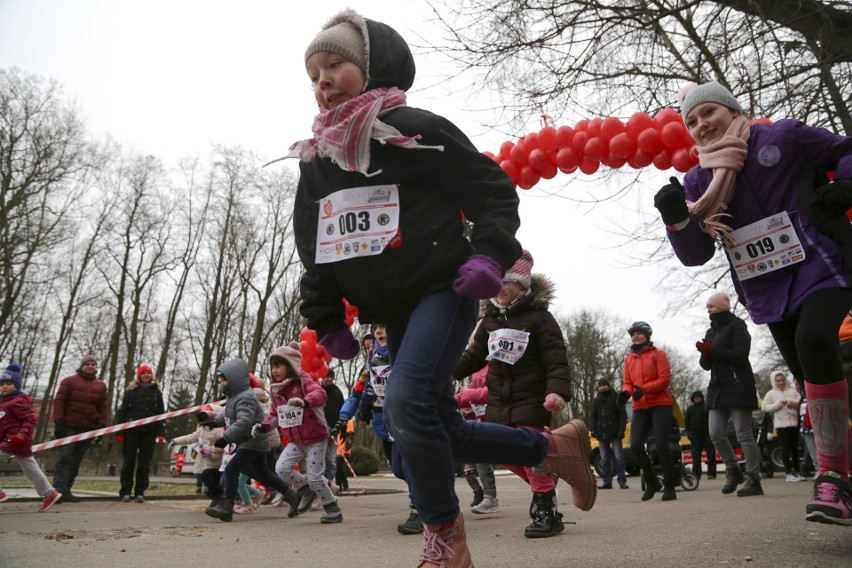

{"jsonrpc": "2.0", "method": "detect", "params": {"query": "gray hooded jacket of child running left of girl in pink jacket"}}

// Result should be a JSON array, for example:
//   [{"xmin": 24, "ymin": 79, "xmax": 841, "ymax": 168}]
[{"xmin": 215, "ymin": 359, "xmax": 269, "ymax": 452}]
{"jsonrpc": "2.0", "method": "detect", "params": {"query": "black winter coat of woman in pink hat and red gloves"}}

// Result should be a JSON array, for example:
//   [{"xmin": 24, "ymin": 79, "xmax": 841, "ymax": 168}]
[{"xmin": 698, "ymin": 312, "xmax": 757, "ymax": 410}]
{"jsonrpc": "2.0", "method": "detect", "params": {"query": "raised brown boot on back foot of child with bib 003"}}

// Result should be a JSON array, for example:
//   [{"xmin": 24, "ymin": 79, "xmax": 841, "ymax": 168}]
[{"xmin": 541, "ymin": 419, "xmax": 598, "ymax": 511}]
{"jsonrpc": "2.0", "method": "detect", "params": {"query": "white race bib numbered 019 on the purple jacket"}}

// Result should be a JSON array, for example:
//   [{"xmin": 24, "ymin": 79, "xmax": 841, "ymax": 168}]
[{"xmin": 726, "ymin": 211, "xmax": 805, "ymax": 280}]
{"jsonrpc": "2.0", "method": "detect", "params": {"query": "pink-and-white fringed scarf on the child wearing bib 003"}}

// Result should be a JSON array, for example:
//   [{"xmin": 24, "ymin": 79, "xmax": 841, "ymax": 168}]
[{"xmin": 286, "ymin": 87, "xmax": 444, "ymax": 177}]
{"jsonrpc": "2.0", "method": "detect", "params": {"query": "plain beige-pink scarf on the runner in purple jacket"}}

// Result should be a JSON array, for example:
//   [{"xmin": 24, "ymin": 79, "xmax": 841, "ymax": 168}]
[{"xmin": 687, "ymin": 115, "xmax": 750, "ymax": 245}]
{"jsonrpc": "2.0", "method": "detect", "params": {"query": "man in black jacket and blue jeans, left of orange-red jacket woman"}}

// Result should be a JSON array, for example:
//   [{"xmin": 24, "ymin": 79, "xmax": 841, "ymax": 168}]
[{"xmin": 592, "ymin": 377, "xmax": 628, "ymax": 489}]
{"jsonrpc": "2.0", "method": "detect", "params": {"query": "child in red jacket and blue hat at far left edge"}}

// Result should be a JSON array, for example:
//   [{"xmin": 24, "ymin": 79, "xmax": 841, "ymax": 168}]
[{"xmin": 0, "ymin": 363, "xmax": 62, "ymax": 512}]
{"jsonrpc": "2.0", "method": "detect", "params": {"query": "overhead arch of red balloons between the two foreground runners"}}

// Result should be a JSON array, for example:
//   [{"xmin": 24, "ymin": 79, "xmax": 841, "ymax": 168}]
[{"xmin": 484, "ymin": 108, "xmax": 771, "ymax": 189}]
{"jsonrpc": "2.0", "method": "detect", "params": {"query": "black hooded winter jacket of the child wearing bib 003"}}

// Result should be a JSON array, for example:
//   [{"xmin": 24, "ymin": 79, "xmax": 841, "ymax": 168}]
[{"xmin": 294, "ymin": 15, "xmax": 521, "ymax": 338}]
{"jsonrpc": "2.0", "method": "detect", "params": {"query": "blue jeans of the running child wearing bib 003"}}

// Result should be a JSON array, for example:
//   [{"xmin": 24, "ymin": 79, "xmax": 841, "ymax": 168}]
[{"xmin": 384, "ymin": 288, "xmax": 547, "ymax": 525}]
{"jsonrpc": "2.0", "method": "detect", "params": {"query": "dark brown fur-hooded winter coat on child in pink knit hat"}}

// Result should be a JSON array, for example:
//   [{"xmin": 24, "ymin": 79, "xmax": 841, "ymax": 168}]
[{"xmin": 453, "ymin": 274, "xmax": 571, "ymax": 426}]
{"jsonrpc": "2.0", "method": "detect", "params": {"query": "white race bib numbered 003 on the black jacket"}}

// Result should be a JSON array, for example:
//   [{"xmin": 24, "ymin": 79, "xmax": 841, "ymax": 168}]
[{"xmin": 316, "ymin": 185, "xmax": 399, "ymax": 264}]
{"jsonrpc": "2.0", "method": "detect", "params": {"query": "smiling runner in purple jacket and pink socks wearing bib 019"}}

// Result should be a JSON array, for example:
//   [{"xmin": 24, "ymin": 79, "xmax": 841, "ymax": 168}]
[{"xmin": 654, "ymin": 82, "xmax": 852, "ymax": 525}]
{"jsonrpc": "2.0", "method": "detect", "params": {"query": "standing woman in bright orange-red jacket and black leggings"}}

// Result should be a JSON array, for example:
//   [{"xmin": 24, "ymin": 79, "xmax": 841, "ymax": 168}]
[{"xmin": 619, "ymin": 321, "xmax": 677, "ymax": 501}]
